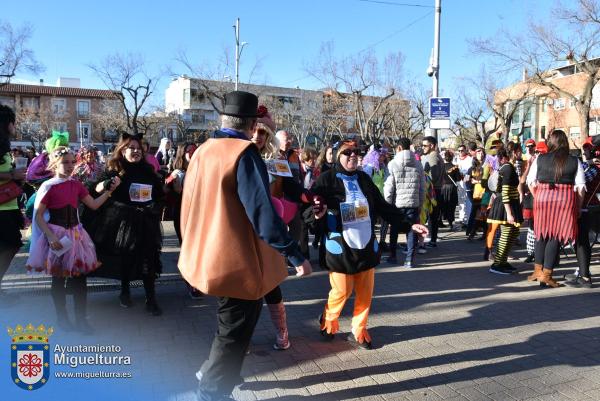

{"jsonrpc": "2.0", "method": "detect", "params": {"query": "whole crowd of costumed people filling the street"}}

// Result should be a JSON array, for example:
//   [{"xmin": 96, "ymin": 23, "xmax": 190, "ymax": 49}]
[{"xmin": 0, "ymin": 91, "xmax": 600, "ymax": 400}]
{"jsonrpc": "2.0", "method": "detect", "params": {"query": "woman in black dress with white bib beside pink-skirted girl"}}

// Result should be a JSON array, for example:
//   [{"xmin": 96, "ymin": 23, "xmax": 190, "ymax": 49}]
[{"xmin": 83, "ymin": 134, "xmax": 164, "ymax": 316}]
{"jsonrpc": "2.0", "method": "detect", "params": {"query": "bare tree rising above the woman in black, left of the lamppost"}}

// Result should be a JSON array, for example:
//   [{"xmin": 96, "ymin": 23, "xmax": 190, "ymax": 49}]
[{"xmin": 89, "ymin": 53, "xmax": 158, "ymax": 135}]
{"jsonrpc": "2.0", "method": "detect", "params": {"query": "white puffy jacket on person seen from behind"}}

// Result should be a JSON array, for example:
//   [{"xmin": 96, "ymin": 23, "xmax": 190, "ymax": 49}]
[{"xmin": 383, "ymin": 150, "xmax": 425, "ymax": 208}]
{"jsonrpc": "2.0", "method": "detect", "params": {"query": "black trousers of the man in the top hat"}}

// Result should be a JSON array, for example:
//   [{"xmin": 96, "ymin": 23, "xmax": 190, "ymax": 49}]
[{"xmin": 199, "ymin": 297, "xmax": 263, "ymax": 395}]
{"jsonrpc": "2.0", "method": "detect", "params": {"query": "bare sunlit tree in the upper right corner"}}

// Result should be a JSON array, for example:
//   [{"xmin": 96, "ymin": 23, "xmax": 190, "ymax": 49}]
[{"xmin": 471, "ymin": 0, "xmax": 600, "ymax": 140}]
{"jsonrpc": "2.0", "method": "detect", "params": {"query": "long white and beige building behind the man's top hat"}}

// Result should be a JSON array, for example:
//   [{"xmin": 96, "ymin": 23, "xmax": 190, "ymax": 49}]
[{"xmin": 165, "ymin": 76, "xmax": 408, "ymax": 146}]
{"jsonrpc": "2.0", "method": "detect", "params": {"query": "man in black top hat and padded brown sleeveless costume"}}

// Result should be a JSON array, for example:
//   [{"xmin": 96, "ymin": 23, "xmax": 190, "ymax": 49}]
[{"xmin": 179, "ymin": 91, "xmax": 312, "ymax": 401}]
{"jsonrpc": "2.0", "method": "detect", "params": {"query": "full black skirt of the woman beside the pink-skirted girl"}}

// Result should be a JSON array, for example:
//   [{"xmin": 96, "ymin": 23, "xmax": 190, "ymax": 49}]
[{"xmin": 82, "ymin": 201, "xmax": 162, "ymax": 280}]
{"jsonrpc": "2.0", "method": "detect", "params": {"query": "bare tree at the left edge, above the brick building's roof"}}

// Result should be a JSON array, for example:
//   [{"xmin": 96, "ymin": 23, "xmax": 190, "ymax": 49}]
[{"xmin": 0, "ymin": 21, "xmax": 43, "ymax": 86}]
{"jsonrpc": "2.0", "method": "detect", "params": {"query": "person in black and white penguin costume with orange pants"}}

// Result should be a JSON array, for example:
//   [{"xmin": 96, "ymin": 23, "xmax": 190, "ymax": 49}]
[{"xmin": 305, "ymin": 141, "xmax": 427, "ymax": 349}]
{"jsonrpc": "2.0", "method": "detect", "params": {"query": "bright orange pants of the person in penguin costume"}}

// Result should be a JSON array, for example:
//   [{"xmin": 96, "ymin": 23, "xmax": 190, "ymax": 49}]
[{"xmin": 321, "ymin": 269, "xmax": 375, "ymax": 343}]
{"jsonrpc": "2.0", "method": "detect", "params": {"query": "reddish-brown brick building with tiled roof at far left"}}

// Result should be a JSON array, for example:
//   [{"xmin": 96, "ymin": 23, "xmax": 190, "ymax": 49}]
[{"xmin": 0, "ymin": 78, "xmax": 122, "ymax": 148}]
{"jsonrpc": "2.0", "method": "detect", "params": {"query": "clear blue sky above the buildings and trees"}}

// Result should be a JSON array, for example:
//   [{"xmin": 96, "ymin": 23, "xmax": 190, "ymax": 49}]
[{"xmin": 5, "ymin": 0, "xmax": 552, "ymax": 104}]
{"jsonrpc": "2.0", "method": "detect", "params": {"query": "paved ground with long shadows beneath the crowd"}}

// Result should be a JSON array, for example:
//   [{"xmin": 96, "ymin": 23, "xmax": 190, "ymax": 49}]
[{"xmin": 0, "ymin": 225, "xmax": 600, "ymax": 401}]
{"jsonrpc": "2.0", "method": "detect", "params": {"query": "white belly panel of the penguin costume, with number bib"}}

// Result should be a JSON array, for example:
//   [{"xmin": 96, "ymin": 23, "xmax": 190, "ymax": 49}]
[{"xmin": 337, "ymin": 174, "xmax": 371, "ymax": 249}]
